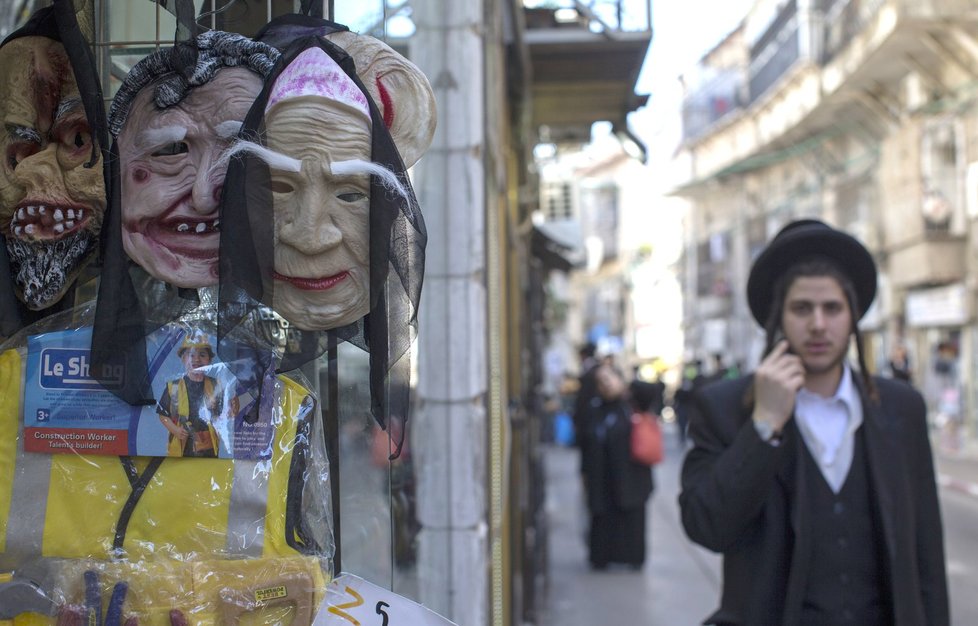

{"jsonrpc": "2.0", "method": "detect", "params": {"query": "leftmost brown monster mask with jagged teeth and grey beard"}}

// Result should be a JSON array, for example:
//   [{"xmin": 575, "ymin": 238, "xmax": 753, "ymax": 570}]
[{"xmin": 0, "ymin": 36, "xmax": 105, "ymax": 310}]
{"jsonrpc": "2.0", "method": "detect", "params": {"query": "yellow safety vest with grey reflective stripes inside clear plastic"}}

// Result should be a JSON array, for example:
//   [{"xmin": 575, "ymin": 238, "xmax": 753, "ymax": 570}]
[{"xmin": 0, "ymin": 350, "xmax": 332, "ymax": 626}]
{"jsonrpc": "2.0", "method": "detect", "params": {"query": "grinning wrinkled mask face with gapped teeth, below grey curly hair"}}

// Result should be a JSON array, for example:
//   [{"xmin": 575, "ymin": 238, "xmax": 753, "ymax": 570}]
[{"xmin": 118, "ymin": 68, "xmax": 262, "ymax": 288}]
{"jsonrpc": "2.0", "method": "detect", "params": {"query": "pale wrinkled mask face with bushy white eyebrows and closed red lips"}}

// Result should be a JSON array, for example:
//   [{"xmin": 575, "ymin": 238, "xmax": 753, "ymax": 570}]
[{"xmin": 265, "ymin": 96, "xmax": 370, "ymax": 330}]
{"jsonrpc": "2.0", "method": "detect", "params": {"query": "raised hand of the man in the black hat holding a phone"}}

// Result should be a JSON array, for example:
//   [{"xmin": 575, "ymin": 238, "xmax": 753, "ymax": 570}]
[{"xmin": 752, "ymin": 339, "xmax": 805, "ymax": 433}]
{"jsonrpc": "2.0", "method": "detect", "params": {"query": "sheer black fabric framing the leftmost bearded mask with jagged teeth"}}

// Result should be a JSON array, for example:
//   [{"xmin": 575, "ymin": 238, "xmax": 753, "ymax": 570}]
[{"xmin": 0, "ymin": 0, "xmax": 108, "ymax": 337}]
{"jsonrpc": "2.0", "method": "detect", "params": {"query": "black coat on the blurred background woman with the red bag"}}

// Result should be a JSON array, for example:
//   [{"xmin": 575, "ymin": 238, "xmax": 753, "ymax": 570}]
[{"xmin": 579, "ymin": 397, "xmax": 653, "ymax": 514}]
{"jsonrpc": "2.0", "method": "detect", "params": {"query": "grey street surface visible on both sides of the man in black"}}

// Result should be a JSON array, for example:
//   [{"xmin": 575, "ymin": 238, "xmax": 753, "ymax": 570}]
[{"xmin": 541, "ymin": 424, "xmax": 978, "ymax": 626}]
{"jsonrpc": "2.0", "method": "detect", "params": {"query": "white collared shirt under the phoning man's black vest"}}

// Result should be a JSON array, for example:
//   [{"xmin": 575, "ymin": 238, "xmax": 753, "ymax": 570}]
[{"xmin": 795, "ymin": 364, "xmax": 863, "ymax": 493}]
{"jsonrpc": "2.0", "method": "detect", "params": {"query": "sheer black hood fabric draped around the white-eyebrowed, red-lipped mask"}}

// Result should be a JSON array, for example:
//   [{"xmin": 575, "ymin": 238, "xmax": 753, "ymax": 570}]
[{"xmin": 218, "ymin": 15, "xmax": 427, "ymax": 449}]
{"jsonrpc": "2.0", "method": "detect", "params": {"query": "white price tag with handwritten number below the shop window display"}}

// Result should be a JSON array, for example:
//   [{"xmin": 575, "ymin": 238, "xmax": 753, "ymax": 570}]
[{"xmin": 313, "ymin": 574, "xmax": 455, "ymax": 626}]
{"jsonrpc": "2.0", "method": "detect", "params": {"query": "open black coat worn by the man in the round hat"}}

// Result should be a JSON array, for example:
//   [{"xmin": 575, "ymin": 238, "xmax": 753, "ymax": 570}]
[{"xmin": 679, "ymin": 376, "xmax": 950, "ymax": 626}]
